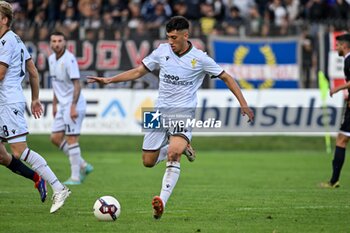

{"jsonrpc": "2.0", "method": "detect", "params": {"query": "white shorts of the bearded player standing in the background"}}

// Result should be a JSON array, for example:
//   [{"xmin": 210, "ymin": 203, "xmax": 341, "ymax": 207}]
[{"xmin": 51, "ymin": 106, "xmax": 85, "ymax": 135}]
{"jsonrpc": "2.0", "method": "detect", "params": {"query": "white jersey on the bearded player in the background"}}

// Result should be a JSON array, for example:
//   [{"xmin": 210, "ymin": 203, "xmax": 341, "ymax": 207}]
[{"xmin": 49, "ymin": 50, "xmax": 86, "ymax": 109}]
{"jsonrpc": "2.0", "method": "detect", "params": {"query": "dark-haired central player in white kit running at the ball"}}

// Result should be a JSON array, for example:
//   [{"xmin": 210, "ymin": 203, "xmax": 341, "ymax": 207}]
[{"xmin": 88, "ymin": 16, "xmax": 254, "ymax": 219}]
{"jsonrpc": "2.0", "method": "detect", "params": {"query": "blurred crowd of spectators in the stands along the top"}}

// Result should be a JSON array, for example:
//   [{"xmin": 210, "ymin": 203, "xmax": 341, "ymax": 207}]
[{"xmin": 8, "ymin": 0, "xmax": 350, "ymax": 87}]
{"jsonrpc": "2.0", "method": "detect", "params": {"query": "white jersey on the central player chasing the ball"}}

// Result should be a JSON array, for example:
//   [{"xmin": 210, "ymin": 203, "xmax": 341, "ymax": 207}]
[{"xmin": 142, "ymin": 43, "xmax": 223, "ymax": 108}]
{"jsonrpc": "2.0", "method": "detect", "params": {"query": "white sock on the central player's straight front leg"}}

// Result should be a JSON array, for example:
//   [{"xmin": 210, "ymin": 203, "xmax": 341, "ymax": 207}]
[{"xmin": 160, "ymin": 161, "xmax": 180, "ymax": 206}]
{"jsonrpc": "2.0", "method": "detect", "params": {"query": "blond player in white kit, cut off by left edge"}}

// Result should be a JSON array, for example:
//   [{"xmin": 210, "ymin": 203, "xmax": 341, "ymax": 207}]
[{"xmin": 0, "ymin": 1, "xmax": 70, "ymax": 213}]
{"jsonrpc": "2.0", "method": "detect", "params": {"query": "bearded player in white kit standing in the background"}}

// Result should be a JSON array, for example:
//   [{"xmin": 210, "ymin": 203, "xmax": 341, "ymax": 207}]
[{"xmin": 49, "ymin": 32, "xmax": 93, "ymax": 185}]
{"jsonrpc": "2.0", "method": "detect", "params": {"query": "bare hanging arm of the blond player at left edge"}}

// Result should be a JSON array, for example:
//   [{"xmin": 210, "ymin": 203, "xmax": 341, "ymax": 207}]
[{"xmin": 26, "ymin": 59, "xmax": 43, "ymax": 119}]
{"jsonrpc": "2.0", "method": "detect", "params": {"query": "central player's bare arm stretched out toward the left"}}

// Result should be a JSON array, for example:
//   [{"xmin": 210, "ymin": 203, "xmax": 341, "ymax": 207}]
[{"xmin": 87, "ymin": 64, "xmax": 149, "ymax": 85}]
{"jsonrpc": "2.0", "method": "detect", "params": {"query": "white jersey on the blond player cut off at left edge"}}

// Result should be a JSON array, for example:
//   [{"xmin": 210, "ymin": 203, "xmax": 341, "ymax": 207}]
[{"xmin": 0, "ymin": 31, "xmax": 31, "ymax": 105}]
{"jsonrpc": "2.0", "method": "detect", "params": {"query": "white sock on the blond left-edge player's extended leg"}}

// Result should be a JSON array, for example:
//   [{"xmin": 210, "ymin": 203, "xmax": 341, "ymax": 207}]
[{"xmin": 21, "ymin": 148, "xmax": 64, "ymax": 192}]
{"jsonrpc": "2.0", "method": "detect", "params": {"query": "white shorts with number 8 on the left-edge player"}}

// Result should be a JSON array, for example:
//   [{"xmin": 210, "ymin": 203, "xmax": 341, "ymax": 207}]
[{"xmin": 0, "ymin": 103, "xmax": 28, "ymax": 143}]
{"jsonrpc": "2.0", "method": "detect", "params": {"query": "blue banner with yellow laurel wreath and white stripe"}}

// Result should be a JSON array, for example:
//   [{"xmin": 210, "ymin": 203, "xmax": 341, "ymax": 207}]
[{"xmin": 209, "ymin": 36, "xmax": 300, "ymax": 89}]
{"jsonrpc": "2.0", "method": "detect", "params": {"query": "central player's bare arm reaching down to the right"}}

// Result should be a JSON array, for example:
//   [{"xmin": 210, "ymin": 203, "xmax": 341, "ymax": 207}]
[{"xmin": 219, "ymin": 71, "xmax": 254, "ymax": 122}]
